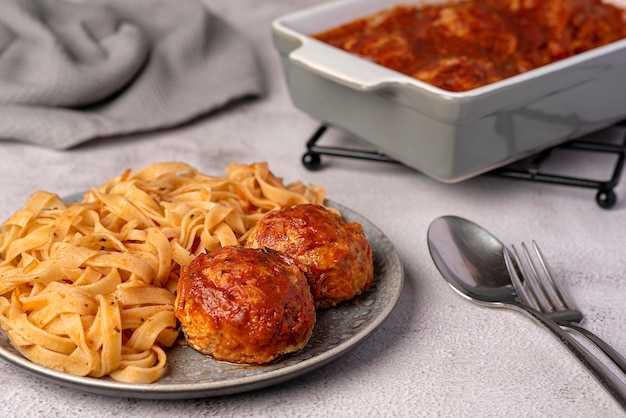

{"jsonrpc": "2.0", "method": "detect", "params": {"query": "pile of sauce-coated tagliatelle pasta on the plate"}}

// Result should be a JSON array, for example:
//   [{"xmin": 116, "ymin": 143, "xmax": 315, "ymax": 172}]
[{"xmin": 0, "ymin": 162, "xmax": 325, "ymax": 383}]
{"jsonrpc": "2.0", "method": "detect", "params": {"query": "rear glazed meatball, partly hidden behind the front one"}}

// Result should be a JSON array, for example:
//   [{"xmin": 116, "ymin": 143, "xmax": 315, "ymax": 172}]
[{"xmin": 246, "ymin": 204, "xmax": 374, "ymax": 309}]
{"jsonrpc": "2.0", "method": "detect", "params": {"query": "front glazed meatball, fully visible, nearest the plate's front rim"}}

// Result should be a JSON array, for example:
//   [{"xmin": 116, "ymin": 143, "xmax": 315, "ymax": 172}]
[{"xmin": 175, "ymin": 246, "xmax": 315, "ymax": 364}]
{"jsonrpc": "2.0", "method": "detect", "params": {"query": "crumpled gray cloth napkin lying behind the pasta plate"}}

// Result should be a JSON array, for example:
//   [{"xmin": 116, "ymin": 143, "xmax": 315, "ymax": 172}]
[{"xmin": 0, "ymin": 0, "xmax": 262, "ymax": 149}]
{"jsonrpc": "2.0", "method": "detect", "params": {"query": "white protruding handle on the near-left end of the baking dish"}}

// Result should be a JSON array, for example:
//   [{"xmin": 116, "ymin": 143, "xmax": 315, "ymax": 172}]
[{"xmin": 289, "ymin": 40, "xmax": 406, "ymax": 91}]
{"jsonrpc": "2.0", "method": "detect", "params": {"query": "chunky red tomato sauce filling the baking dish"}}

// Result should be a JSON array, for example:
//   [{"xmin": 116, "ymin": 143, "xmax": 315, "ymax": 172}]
[{"xmin": 314, "ymin": 0, "xmax": 626, "ymax": 92}]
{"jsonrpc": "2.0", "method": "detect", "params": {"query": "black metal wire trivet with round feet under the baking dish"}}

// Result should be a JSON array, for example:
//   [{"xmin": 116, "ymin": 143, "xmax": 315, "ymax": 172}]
[{"xmin": 302, "ymin": 122, "xmax": 626, "ymax": 209}]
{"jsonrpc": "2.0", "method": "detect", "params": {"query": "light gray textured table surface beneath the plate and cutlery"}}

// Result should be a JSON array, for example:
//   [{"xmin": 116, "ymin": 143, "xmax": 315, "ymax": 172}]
[{"xmin": 0, "ymin": 0, "xmax": 626, "ymax": 417}]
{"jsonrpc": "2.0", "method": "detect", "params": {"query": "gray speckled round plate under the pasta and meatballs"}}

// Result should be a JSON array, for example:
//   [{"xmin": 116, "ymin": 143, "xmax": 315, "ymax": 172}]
[{"xmin": 0, "ymin": 199, "xmax": 404, "ymax": 399}]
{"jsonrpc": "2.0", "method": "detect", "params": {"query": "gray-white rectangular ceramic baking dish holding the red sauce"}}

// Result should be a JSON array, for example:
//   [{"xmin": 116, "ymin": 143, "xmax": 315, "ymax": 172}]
[{"xmin": 272, "ymin": 0, "xmax": 626, "ymax": 182}]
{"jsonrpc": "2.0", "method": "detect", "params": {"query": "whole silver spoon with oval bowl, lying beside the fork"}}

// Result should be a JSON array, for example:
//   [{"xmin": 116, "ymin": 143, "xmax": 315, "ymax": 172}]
[{"xmin": 428, "ymin": 216, "xmax": 626, "ymax": 410}]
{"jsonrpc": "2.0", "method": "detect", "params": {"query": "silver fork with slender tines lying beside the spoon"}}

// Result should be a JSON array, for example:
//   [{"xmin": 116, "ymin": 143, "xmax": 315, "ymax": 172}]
[{"xmin": 511, "ymin": 241, "xmax": 626, "ymax": 373}]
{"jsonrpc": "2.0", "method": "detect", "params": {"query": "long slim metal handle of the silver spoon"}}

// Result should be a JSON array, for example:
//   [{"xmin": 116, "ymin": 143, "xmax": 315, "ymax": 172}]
[{"xmin": 511, "ymin": 302, "xmax": 626, "ymax": 410}]
